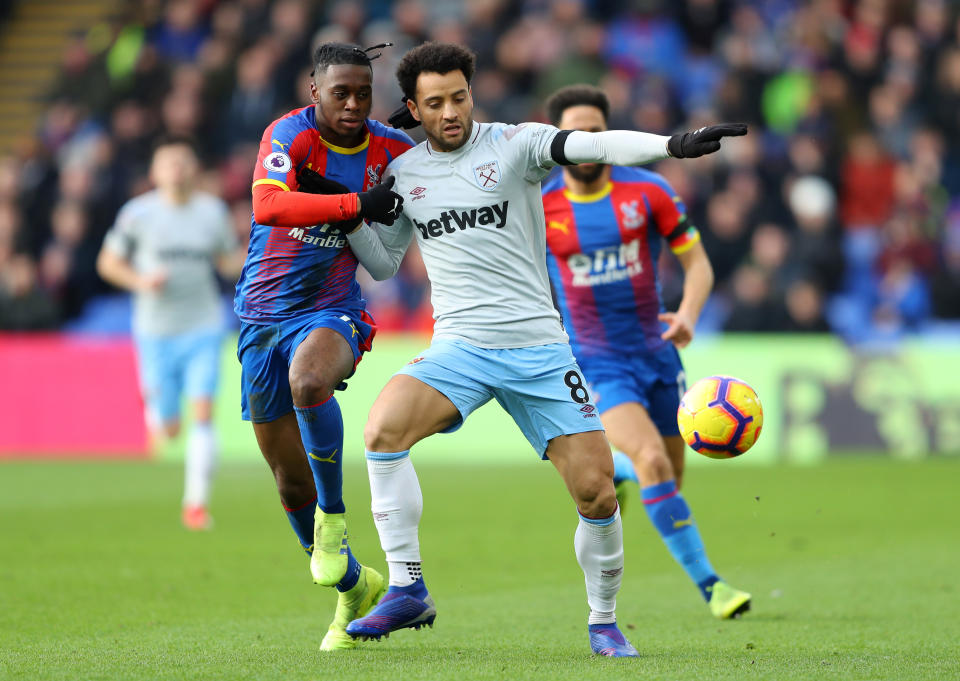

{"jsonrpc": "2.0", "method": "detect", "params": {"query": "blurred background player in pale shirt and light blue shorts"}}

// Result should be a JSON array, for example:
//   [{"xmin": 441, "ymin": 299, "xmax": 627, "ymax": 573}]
[{"xmin": 97, "ymin": 137, "xmax": 242, "ymax": 530}]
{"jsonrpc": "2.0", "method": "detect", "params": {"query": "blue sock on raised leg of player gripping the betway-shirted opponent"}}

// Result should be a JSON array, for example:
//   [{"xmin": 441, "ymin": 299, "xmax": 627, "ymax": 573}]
[{"xmin": 294, "ymin": 396, "xmax": 347, "ymax": 513}]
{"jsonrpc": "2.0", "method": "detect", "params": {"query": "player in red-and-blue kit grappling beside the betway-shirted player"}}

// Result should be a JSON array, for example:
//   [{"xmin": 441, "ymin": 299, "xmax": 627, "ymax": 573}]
[{"xmin": 234, "ymin": 43, "xmax": 413, "ymax": 650}]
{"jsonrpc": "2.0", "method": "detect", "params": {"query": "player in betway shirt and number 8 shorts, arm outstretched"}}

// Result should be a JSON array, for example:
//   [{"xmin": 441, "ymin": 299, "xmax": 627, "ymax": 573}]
[{"xmin": 347, "ymin": 43, "xmax": 745, "ymax": 657}]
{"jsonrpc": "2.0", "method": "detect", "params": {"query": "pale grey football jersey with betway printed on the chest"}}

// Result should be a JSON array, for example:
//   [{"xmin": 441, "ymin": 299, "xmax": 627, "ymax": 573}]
[{"xmin": 377, "ymin": 123, "xmax": 567, "ymax": 348}]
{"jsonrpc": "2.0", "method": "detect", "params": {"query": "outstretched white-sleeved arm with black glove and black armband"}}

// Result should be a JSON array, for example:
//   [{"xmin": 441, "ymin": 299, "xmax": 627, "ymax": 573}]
[{"xmin": 550, "ymin": 123, "xmax": 747, "ymax": 166}]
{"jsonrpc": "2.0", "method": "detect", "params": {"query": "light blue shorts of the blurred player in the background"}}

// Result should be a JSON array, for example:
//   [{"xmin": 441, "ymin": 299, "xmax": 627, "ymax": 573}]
[{"xmin": 134, "ymin": 329, "xmax": 223, "ymax": 425}]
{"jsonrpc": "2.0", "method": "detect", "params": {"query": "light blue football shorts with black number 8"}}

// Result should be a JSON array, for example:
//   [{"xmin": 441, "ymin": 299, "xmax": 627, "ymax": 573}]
[{"xmin": 397, "ymin": 338, "xmax": 603, "ymax": 459}]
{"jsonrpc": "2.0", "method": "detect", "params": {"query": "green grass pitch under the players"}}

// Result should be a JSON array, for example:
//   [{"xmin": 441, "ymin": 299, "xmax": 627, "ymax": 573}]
[{"xmin": 0, "ymin": 453, "xmax": 960, "ymax": 681}]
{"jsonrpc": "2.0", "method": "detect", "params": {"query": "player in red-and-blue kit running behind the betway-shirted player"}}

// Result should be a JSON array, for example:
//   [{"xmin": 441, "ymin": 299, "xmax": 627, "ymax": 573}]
[{"xmin": 543, "ymin": 85, "xmax": 750, "ymax": 618}]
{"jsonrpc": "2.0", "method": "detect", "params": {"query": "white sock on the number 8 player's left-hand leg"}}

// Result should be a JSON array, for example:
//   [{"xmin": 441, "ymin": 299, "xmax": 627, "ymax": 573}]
[{"xmin": 367, "ymin": 451, "xmax": 423, "ymax": 586}]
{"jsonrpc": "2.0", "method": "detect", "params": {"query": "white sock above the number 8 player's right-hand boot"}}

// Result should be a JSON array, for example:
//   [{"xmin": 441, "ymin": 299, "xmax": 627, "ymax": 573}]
[{"xmin": 573, "ymin": 508, "xmax": 623, "ymax": 624}]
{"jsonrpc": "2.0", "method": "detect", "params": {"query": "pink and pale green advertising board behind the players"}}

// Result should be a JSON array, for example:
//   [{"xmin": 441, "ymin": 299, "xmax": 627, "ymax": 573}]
[{"xmin": 0, "ymin": 335, "xmax": 960, "ymax": 465}]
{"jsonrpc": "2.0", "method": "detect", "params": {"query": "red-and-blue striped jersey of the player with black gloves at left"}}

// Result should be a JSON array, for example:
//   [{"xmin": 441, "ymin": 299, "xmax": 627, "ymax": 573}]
[{"xmin": 234, "ymin": 106, "xmax": 414, "ymax": 323}]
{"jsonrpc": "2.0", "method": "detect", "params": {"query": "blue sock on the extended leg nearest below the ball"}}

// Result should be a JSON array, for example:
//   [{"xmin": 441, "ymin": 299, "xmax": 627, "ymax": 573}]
[{"xmin": 640, "ymin": 480, "xmax": 719, "ymax": 601}]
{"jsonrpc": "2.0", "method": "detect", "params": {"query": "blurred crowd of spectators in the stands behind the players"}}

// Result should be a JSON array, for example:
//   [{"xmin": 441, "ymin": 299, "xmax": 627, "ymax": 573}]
[{"xmin": 0, "ymin": 0, "xmax": 960, "ymax": 342}]
